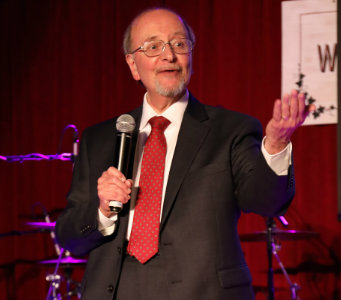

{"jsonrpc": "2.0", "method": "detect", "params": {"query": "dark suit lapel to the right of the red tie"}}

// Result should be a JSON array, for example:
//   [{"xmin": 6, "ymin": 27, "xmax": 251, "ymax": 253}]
[{"xmin": 160, "ymin": 95, "xmax": 210, "ymax": 230}]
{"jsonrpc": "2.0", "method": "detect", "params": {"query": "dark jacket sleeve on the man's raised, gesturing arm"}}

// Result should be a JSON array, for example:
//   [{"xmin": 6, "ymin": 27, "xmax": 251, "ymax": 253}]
[{"xmin": 231, "ymin": 118, "xmax": 295, "ymax": 216}]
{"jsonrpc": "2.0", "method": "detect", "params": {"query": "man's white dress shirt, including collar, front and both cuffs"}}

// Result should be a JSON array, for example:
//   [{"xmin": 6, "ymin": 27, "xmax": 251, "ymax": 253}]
[{"xmin": 98, "ymin": 91, "xmax": 292, "ymax": 236}]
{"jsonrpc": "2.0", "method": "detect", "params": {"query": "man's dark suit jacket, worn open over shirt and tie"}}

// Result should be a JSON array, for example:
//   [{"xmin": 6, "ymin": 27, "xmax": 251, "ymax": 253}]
[{"xmin": 56, "ymin": 95, "xmax": 294, "ymax": 299}]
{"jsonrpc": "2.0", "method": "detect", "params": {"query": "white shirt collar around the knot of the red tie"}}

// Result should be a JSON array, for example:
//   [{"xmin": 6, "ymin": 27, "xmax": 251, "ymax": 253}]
[{"xmin": 140, "ymin": 90, "xmax": 189, "ymax": 130}]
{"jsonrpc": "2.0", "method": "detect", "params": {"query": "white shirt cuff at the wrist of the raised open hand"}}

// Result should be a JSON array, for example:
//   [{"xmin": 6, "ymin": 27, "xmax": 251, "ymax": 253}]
[{"xmin": 261, "ymin": 137, "xmax": 292, "ymax": 176}]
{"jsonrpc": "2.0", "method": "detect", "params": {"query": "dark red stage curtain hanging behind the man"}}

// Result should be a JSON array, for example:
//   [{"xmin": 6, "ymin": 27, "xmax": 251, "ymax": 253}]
[{"xmin": 0, "ymin": 0, "xmax": 341, "ymax": 299}]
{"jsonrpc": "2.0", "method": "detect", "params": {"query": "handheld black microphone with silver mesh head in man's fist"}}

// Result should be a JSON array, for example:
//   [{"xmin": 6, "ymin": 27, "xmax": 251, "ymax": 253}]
[{"xmin": 109, "ymin": 114, "xmax": 136, "ymax": 213}]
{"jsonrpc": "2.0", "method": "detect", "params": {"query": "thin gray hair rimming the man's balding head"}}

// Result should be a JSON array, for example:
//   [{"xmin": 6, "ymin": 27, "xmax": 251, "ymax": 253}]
[{"xmin": 123, "ymin": 7, "xmax": 195, "ymax": 54}]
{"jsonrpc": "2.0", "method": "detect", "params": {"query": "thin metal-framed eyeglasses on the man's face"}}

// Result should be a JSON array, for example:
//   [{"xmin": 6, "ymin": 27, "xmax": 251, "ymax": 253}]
[{"xmin": 129, "ymin": 39, "xmax": 193, "ymax": 57}]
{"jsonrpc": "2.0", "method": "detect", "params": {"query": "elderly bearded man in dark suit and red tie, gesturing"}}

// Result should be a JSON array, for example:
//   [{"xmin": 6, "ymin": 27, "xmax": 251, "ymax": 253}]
[{"xmin": 56, "ymin": 8, "xmax": 311, "ymax": 300}]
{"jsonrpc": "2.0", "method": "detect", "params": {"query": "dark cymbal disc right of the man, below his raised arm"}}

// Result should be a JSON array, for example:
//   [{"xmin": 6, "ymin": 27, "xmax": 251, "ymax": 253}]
[{"xmin": 239, "ymin": 228, "xmax": 319, "ymax": 242}]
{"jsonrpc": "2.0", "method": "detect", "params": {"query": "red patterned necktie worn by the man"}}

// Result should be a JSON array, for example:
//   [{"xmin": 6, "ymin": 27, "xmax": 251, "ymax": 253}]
[{"xmin": 127, "ymin": 117, "xmax": 170, "ymax": 263}]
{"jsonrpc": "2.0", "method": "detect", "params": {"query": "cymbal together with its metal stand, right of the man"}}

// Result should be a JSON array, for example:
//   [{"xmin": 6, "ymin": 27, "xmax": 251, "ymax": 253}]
[{"xmin": 240, "ymin": 216, "xmax": 319, "ymax": 300}]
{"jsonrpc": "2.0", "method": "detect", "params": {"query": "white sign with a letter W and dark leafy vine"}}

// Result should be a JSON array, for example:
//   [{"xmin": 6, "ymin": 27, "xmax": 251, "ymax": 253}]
[{"xmin": 282, "ymin": 0, "xmax": 337, "ymax": 125}]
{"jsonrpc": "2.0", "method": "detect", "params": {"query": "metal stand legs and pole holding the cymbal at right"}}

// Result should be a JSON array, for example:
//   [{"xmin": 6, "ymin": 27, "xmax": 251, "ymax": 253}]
[{"xmin": 266, "ymin": 218, "xmax": 300, "ymax": 300}]
